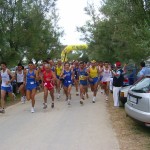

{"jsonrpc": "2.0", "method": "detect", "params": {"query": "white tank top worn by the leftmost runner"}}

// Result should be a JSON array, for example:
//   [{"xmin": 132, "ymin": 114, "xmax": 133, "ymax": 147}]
[{"xmin": 1, "ymin": 69, "xmax": 11, "ymax": 87}]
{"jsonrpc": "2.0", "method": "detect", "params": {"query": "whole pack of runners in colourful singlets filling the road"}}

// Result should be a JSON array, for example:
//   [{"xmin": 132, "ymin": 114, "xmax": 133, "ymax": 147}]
[{"xmin": 0, "ymin": 60, "xmax": 112, "ymax": 113}]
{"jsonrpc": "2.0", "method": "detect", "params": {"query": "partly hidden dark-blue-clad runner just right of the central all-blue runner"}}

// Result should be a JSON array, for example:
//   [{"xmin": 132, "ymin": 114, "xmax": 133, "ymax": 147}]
[{"xmin": 73, "ymin": 60, "xmax": 79, "ymax": 96}]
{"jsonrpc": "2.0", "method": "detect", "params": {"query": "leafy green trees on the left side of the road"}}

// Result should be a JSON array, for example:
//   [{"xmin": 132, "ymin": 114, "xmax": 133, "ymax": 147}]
[{"xmin": 0, "ymin": 0, "xmax": 63, "ymax": 65}]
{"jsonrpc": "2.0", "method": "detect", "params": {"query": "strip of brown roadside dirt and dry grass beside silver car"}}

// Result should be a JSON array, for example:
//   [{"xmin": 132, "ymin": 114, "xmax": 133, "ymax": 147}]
[{"xmin": 107, "ymin": 94, "xmax": 150, "ymax": 150}]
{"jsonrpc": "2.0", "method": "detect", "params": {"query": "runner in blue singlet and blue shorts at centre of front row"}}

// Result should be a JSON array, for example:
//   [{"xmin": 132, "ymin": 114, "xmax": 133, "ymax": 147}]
[{"xmin": 60, "ymin": 62, "xmax": 74, "ymax": 105}]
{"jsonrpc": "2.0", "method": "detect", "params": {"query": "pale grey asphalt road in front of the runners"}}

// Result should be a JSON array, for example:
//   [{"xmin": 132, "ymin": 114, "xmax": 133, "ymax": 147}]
[{"xmin": 0, "ymin": 88, "xmax": 119, "ymax": 150}]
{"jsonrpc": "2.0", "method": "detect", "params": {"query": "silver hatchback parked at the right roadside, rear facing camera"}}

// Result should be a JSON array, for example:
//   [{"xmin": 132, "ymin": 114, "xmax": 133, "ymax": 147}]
[{"xmin": 125, "ymin": 76, "xmax": 150, "ymax": 126}]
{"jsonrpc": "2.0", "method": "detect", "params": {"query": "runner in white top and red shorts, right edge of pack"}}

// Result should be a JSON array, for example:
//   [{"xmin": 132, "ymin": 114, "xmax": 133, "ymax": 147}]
[{"xmin": 101, "ymin": 62, "xmax": 112, "ymax": 101}]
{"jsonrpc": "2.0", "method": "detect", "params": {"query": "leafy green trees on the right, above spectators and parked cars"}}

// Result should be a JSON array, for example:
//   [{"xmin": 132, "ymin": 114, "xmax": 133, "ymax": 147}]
[{"xmin": 78, "ymin": 0, "xmax": 150, "ymax": 63}]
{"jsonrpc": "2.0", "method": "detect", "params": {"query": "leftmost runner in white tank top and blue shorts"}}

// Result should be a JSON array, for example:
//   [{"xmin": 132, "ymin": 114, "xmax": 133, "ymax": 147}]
[{"xmin": 0, "ymin": 62, "xmax": 15, "ymax": 113}]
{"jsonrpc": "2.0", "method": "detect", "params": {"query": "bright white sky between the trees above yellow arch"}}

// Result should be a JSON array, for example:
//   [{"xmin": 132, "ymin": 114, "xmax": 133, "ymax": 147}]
[{"xmin": 57, "ymin": 0, "xmax": 100, "ymax": 45}]
